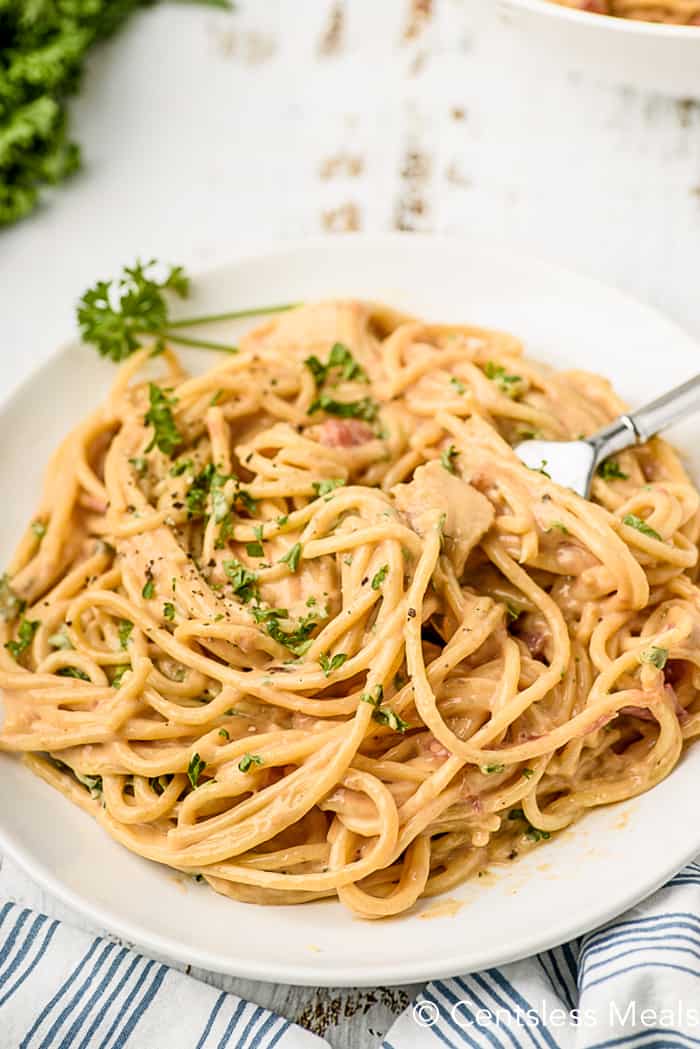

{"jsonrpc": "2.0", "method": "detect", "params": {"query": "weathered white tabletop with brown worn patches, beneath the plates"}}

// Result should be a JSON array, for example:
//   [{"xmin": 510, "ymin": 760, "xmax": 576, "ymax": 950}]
[{"xmin": 0, "ymin": 0, "xmax": 700, "ymax": 1049}]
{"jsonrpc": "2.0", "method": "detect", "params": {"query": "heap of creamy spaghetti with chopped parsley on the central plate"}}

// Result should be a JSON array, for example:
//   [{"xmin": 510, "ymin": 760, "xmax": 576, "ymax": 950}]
[{"xmin": 0, "ymin": 301, "xmax": 700, "ymax": 918}]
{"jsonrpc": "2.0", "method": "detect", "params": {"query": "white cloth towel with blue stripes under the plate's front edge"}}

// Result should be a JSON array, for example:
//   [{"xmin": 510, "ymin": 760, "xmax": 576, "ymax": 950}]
[{"xmin": 0, "ymin": 861, "xmax": 700, "ymax": 1049}]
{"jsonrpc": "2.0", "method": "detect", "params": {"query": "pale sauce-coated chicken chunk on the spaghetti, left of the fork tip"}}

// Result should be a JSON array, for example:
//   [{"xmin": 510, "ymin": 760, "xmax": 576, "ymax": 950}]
[{"xmin": 391, "ymin": 462, "xmax": 494, "ymax": 579}]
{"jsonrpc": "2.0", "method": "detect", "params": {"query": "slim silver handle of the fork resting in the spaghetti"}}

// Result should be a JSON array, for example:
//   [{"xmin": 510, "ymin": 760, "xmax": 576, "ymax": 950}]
[{"xmin": 588, "ymin": 374, "xmax": 700, "ymax": 466}]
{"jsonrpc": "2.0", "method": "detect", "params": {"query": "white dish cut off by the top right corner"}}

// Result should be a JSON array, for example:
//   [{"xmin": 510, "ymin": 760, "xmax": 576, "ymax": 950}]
[{"xmin": 493, "ymin": 0, "xmax": 700, "ymax": 97}]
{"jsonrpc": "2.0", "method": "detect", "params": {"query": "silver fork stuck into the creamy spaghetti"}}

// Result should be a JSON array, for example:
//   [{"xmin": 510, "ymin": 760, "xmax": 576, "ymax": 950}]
[{"xmin": 514, "ymin": 374, "xmax": 700, "ymax": 498}]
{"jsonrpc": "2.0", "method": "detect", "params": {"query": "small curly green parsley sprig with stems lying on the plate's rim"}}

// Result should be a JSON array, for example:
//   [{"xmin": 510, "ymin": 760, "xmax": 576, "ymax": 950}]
[{"xmin": 78, "ymin": 259, "xmax": 296, "ymax": 364}]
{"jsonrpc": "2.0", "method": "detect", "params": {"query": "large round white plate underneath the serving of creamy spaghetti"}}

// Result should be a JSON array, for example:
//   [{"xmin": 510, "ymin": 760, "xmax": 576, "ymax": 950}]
[{"xmin": 0, "ymin": 236, "xmax": 700, "ymax": 986}]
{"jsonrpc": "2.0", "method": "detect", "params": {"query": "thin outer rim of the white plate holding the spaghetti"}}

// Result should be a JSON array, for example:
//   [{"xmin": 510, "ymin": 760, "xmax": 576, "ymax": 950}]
[{"xmin": 0, "ymin": 233, "xmax": 700, "ymax": 987}]
